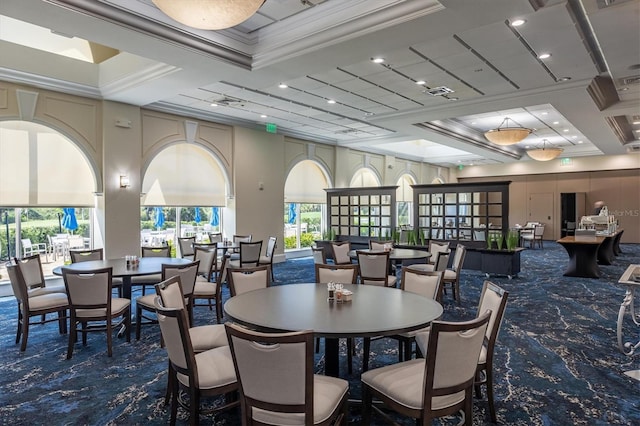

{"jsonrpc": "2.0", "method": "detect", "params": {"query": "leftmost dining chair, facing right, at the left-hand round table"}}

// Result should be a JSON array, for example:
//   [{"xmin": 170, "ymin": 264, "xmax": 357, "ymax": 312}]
[{"xmin": 7, "ymin": 262, "xmax": 69, "ymax": 352}]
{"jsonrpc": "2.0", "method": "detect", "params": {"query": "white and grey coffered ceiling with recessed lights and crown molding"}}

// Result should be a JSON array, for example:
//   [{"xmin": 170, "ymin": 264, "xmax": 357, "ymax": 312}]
[{"xmin": 0, "ymin": 0, "xmax": 640, "ymax": 167}]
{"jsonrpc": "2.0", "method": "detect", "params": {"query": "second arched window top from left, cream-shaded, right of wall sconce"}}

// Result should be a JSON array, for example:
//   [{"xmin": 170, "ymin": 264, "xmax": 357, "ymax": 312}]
[{"xmin": 142, "ymin": 142, "xmax": 227, "ymax": 206}]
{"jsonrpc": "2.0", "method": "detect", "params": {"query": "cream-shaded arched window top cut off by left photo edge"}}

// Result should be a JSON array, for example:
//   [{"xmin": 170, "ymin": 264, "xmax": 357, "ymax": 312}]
[{"xmin": 0, "ymin": 121, "xmax": 97, "ymax": 207}]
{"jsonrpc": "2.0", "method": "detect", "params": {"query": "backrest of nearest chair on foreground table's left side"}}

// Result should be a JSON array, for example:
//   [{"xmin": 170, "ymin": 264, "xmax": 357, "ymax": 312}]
[{"xmin": 154, "ymin": 296, "xmax": 200, "ymax": 380}]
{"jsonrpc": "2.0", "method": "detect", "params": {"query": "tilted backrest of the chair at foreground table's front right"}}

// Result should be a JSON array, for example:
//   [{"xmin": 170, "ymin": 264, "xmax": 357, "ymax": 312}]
[{"xmin": 423, "ymin": 312, "xmax": 490, "ymax": 412}]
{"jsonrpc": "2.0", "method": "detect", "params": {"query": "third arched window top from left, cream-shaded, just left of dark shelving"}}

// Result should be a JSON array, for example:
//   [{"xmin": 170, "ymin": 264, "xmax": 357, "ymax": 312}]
[{"xmin": 284, "ymin": 160, "xmax": 329, "ymax": 203}]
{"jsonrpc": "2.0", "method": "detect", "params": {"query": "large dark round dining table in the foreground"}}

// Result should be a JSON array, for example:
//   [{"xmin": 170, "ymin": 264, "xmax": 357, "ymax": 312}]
[{"xmin": 224, "ymin": 283, "xmax": 443, "ymax": 377}]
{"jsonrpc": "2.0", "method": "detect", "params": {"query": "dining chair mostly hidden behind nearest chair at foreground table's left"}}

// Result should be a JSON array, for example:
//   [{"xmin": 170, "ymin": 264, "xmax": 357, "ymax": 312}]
[{"xmin": 154, "ymin": 275, "xmax": 229, "ymax": 405}]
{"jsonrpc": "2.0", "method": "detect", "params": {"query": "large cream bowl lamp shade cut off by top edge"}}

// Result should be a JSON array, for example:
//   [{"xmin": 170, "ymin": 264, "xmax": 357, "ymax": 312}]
[{"xmin": 153, "ymin": 0, "xmax": 264, "ymax": 30}]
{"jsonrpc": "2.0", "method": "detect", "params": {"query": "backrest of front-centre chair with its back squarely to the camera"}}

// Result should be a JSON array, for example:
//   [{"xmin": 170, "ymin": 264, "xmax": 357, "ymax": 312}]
[{"xmin": 225, "ymin": 323, "xmax": 314, "ymax": 425}]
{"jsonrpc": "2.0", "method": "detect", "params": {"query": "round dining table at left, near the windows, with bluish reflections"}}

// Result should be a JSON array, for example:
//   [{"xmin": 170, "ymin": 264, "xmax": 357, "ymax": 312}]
[{"xmin": 53, "ymin": 257, "xmax": 191, "ymax": 299}]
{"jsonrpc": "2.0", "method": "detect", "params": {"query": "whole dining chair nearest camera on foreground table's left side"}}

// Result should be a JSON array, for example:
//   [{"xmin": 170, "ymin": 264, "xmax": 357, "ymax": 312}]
[{"xmin": 154, "ymin": 296, "xmax": 239, "ymax": 425}]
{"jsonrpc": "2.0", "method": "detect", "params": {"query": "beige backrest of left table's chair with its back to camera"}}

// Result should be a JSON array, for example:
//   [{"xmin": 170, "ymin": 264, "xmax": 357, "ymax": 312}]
[{"xmin": 62, "ymin": 267, "xmax": 112, "ymax": 308}]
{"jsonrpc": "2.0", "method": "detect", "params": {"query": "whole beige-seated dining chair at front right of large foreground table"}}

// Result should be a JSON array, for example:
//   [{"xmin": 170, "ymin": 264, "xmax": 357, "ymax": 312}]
[{"xmin": 361, "ymin": 312, "xmax": 491, "ymax": 426}]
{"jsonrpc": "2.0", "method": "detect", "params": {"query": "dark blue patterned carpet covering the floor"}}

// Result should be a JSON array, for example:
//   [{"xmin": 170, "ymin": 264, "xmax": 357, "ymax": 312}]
[{"xmin": 0, "ymin": 242, "xmax": 640, "ymax": 425}]
